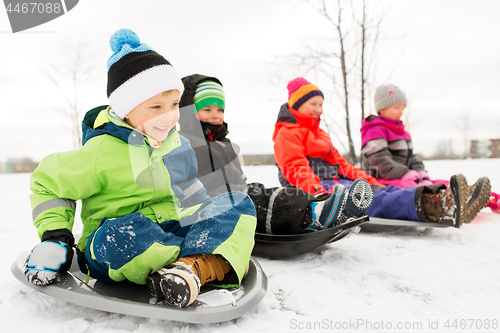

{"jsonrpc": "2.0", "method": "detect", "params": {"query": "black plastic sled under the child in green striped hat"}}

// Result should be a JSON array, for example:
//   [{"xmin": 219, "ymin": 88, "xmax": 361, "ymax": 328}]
[{"xmin": 252, "ymin": 216, "xmax": 369, "ymax": 259}]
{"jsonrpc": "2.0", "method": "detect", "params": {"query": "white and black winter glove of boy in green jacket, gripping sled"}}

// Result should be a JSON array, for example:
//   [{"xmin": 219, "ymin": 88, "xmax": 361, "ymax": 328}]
[{"xmin": 24, "ymin": 229, "xmax": 74, "ymax": 286}]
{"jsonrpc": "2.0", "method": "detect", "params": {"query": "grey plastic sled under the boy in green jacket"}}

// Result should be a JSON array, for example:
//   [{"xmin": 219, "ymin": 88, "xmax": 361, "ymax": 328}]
[{"xmin": 11, "ymin": 251, "xmax": 267, "ymax": 324}]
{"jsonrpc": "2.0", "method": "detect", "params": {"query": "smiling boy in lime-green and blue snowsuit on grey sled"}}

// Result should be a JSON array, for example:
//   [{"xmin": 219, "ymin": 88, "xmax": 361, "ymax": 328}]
[{"xmin": 25, "ymin": 29, "xmax": 256, "ymax": 307}]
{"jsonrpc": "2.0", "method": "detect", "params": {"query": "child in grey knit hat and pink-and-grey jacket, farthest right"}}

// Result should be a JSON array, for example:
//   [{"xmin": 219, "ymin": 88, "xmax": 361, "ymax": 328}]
[{"xmin": 361, "ymin": 84, "xmax": 500, "ymax": 213}]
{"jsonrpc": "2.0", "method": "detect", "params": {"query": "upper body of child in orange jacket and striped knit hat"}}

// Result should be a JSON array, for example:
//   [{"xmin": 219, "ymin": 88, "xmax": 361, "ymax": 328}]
[{"xmin": 273, "ymin": 78, "xmax": 385, "ymax": 193}]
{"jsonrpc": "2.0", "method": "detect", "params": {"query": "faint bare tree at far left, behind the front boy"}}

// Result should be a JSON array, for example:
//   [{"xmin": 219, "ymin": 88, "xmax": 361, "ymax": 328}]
[{"xmin": 39, "ymin": 37, "xmax": 99, "ymax": 149}]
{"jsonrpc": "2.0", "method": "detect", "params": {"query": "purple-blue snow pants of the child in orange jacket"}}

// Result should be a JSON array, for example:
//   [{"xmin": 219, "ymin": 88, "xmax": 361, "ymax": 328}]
[{"xmin": 321, "ymin": 179, "xmax": 421, "ymax": 221}]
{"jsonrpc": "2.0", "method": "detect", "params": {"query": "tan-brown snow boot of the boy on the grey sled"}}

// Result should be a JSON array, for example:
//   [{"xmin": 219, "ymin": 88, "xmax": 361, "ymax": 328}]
[{"xmin": 147, "ymin": 254, "xmax": 231, "ymax": 308}]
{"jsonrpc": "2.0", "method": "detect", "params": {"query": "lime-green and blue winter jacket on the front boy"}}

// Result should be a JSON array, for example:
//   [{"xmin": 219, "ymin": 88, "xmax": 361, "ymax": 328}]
[{"xmin": 30, "ymin": 106, "xmax": 209, "ymax": 251}]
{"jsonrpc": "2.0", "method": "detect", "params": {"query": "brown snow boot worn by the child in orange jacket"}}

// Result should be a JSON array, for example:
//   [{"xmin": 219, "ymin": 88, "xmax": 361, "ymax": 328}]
[{"xmin": 422, "ymin": 174, "xmax": 470, "ymax": 228}]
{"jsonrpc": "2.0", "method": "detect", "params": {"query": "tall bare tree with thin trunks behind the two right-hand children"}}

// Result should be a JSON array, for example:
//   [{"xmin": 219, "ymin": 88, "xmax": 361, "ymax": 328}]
[{"xmin": 281, "ymin": 0, "xmax": 384, "ymax": 163}]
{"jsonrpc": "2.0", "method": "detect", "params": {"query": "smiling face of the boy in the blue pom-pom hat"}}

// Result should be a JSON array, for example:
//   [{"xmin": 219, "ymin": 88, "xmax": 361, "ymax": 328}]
[{"xmin": 125, "ymin": 90, "xmax": 180, "ymax": 142}]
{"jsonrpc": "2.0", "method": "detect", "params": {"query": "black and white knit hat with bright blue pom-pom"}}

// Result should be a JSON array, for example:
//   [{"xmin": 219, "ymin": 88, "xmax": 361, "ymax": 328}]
[{"xmin": 107, "ymin": 29, "xmax": 184, "ymax": 118}]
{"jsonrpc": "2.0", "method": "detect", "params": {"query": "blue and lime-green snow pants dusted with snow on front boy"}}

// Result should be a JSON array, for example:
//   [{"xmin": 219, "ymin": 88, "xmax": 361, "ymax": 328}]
[{"xmin": 79, "ymin": 192, "xmax": 257, "ymax": 285}]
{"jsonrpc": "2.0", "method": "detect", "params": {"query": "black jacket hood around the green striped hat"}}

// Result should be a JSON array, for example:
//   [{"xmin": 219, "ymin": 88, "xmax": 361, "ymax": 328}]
[{"xmin": 179, "ymin": 74, "xmax": 222, "ymax": 136}]
